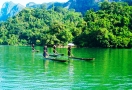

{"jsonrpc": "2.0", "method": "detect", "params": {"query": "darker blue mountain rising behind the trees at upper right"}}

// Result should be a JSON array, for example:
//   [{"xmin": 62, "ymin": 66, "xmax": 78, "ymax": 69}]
[{"xmin": 64, "ymin": 0, "xmax": 132, "ymax": 14}]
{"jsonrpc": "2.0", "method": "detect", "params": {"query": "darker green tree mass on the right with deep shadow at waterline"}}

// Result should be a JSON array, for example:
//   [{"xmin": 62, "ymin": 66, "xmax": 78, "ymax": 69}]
[{"xmin": 75, "ymin": 2, "xmax": 132, "ymax": 48}]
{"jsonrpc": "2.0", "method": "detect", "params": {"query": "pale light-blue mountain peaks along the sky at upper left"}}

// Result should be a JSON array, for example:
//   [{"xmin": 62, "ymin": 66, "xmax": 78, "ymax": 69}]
[{"xmin": 0, "ymin": 1, "xmax": 63, "ymax": 21}]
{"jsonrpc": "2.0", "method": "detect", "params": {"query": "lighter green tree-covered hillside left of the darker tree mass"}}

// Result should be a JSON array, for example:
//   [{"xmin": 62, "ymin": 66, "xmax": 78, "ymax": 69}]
[{"xmin": 0, "ymin": 7, "xmax": 83, "ymax": 45}]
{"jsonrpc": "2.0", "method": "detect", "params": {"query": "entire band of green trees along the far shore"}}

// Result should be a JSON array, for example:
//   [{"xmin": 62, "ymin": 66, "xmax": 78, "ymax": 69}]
[{"xmin": 0, "ymin": 1, "xmax": 132, "ymax": 48}]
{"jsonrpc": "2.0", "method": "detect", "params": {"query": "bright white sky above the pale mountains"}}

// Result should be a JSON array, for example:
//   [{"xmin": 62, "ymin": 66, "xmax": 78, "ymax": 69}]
[{"xmin": 0, "ymin": 0, "xmax": 68, "ymax": 8}]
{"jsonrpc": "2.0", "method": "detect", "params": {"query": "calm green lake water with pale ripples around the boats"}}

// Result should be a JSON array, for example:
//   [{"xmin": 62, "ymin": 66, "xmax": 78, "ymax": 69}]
[{"xmin": 0, "ymin": 46, "xmax": 132, "ymax": 90}]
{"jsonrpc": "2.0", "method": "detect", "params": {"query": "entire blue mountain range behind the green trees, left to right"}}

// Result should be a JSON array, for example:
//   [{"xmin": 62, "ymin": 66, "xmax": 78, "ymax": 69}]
[{"xmin": 0, "ymin": 0, "xmax": 132, "ymax": 21}]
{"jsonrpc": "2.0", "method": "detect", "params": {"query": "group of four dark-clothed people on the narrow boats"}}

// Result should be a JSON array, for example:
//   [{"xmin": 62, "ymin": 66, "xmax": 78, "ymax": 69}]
[{"xmin": 32, "ymin": 44, "xmax": 71, "ymax": 58}]
